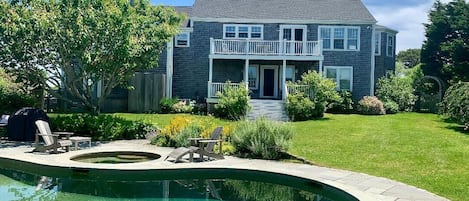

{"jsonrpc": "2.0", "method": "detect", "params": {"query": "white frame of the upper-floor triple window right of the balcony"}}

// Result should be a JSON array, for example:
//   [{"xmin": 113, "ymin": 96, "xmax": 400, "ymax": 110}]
[{"xmin": 318, "ymin": 26, "xmax": 361, "ymax": 51}]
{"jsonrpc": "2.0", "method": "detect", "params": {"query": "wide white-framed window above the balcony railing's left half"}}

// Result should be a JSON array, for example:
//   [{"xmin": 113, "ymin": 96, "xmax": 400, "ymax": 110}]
[{"xmin": 223, "ymin": 24, "xmax": 264, "ymax": 39}]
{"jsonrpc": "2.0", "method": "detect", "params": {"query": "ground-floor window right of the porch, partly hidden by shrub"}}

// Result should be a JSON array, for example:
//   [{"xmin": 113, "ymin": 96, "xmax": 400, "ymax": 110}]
[{"xmin": 325, "ymin": 66, "xmax": 353, "ymax": 91}]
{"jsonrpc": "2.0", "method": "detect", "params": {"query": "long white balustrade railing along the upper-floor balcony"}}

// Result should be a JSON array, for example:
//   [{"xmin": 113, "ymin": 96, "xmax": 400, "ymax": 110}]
[{"xmin": 210, "ymin": 38, "xmax": 322, "ymax": 56}]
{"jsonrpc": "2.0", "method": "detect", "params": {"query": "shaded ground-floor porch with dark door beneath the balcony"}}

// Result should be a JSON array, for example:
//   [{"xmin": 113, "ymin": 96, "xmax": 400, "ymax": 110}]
[{"xmin": 207, "ymin": 59, "xmax": 321, "ymax": 103}]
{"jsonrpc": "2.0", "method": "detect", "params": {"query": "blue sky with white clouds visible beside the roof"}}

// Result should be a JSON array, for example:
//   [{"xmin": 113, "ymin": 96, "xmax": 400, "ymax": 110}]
[{"xmin": 151, "ymin": 0, "xmax": 450, "ymax": 51}]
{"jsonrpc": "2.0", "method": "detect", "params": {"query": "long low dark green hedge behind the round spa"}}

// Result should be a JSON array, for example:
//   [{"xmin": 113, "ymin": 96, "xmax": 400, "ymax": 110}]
[{"xmin": 50, "ymin": 114, "xmax": 156, "ymax": 141}]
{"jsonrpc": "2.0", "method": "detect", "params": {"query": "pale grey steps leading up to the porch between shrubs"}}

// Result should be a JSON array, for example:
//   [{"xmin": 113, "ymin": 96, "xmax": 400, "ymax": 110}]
[{"xmin": 247, "ymin": 99, "xmax": 288, "ymax": 121}]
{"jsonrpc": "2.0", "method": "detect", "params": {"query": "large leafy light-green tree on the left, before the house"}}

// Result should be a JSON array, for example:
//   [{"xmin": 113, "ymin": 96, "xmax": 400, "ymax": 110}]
[{"xmin": 0, "ymin": 0, "xmax": 183, "ymax": 112}]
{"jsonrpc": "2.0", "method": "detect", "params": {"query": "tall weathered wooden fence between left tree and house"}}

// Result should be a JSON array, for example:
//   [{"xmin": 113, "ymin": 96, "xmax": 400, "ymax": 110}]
[{"xmin": 128, "ymin": 72, "xmax": 166, "ymax": 113}]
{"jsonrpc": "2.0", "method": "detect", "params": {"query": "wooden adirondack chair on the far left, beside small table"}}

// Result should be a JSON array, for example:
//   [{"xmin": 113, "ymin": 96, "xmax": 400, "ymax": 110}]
[{"xmin": 33, "ymin": 120, "xmax": 73, "ymax": 153}]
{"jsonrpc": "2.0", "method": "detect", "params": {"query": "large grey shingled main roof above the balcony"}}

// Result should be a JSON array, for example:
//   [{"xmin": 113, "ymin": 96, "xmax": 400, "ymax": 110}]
[{"xmin": 191, "ymin": 0, "xmax": 376, "ymax": 23}]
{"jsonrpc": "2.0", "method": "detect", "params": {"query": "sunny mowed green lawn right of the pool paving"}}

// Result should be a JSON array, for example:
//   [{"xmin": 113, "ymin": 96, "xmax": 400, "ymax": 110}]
[{"xmin": 290, "ymin": 113, "xmax": 469, "ymax": 201}]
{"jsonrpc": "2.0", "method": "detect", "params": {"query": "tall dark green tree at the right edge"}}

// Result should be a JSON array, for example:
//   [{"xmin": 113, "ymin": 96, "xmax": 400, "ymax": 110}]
[{"xmin": 421, "ymin": 0, "xmax": 469, "ymax": 83}]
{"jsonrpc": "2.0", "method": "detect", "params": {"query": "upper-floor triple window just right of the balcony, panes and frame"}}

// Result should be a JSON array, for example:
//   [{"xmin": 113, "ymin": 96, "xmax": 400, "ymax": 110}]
[{"xmin": 319, "ymin": 26, "xmax": 360, "ymax": 51}]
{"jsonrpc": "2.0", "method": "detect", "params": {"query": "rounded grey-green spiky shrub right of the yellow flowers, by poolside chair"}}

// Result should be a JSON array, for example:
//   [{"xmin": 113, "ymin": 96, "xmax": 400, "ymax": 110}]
[{"xmin": 232, "ymin": 118, "xmax": 292, "ymax": 159}]
